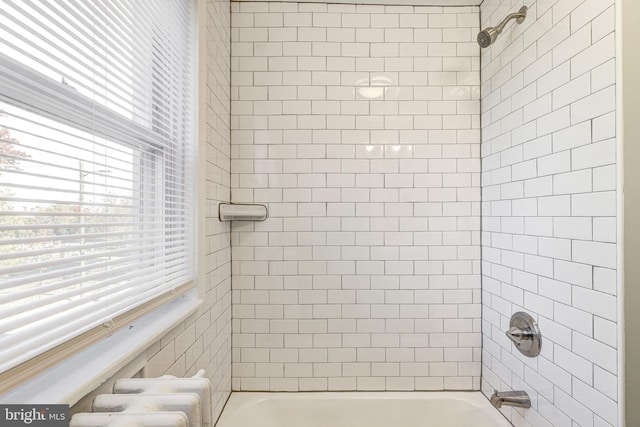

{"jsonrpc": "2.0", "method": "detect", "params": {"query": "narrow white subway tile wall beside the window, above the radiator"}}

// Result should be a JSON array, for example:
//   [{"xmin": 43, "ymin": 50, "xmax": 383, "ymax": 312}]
[{"xmin": 146, "ymin": 0, "xmax": 231, "ymax": 418}]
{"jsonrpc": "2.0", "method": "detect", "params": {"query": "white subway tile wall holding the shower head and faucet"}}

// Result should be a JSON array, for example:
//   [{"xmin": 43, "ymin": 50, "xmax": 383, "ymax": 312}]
[{"xmin": 481, "ymin": 0, "xmax": 619, "ymax": 427}]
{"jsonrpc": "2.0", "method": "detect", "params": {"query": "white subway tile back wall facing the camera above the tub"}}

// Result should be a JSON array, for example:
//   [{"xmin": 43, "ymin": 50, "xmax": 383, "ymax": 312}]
[{"xmin": 231, "ymin": 2, "xmax": 480, "ymax": 391}]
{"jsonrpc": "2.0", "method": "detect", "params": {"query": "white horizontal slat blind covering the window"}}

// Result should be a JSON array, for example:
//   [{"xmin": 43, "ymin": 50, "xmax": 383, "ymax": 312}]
[{"xmin": 0, "ymin": 0, "xmax": 194, "ymax": 372}]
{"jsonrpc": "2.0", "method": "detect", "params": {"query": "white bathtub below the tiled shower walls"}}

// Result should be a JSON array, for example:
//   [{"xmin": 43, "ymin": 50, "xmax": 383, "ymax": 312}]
[{"xmin": 216, "ymin": 392, "xmax": 511, "ymax": 427}]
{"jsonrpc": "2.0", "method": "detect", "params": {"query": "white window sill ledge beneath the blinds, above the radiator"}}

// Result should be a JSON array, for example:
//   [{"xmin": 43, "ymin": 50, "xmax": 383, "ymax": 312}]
[{"xmin": 0, "ymin": 291, "xmax": 202, "ymax": 405}]
